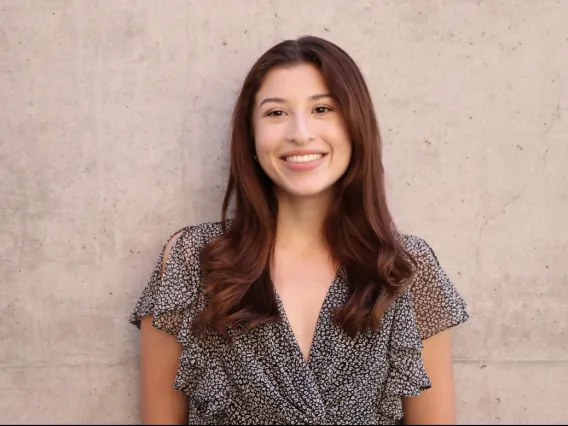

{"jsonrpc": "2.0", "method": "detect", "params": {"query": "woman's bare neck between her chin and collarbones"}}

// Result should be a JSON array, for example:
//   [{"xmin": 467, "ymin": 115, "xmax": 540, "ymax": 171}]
[{"xmin": 276, "ymin": 189, "xmax": 331, "ymax": 249}]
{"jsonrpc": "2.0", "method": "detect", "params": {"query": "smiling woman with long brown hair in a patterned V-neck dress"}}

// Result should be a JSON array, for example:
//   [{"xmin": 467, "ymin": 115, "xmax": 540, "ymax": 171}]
[{"xmin": 131, "ymin": 37, "xmax": 468, "ymax": 424}]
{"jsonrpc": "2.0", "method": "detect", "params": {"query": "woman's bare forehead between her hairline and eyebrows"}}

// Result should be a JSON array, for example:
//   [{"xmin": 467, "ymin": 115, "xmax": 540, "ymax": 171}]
[{"xmin": 256, "ymin": 64, "xmax": 327, "ymax": 104}]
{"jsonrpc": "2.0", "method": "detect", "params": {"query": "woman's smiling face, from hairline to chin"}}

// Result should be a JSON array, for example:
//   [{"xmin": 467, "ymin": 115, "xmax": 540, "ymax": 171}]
[{"xmin": 252, "ymin": 64, "xmax": 351, "ymax": 197}]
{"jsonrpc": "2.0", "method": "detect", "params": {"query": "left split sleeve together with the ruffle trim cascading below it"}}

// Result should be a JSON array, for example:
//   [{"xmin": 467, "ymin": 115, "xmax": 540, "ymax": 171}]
[{"xmin": 130, "ymin": 223, "xmax": 231, "ymax": 424}]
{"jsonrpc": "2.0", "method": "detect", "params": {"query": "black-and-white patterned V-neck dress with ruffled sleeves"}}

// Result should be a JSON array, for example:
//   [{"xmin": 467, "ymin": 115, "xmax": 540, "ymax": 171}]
[{"xmin": 130, "ymin": 222, "xmax": 468, "ymax": 424}]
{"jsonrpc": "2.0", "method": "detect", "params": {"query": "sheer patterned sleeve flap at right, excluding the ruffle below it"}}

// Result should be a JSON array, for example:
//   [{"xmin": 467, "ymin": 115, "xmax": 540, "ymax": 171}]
[{"xmin": 409, "ymin": 237, "xmax": 469, "ymax": 340}]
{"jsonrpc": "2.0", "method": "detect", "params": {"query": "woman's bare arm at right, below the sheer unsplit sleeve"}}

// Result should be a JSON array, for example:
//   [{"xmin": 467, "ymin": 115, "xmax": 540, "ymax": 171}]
[{"xmin": 402, "ymin": 329, "xmax": 456, "ymax": 425}]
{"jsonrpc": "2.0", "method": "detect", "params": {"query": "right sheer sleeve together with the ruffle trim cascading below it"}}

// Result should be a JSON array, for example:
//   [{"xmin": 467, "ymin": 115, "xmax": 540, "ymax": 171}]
[{"xmin": 379, "ymin": 235, "xmax": 468, "ymax": 423}]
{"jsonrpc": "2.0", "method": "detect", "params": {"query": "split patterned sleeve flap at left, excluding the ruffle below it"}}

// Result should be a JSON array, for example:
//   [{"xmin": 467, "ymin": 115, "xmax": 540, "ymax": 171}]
[{"xmin": 130, "ymin": 227, "xmax": 200, "ymax": 343}]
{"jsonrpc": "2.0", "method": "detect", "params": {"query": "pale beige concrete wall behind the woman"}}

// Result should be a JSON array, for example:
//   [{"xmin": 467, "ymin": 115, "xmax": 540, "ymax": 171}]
[{"xmin": 0, "ymin": 0, "xmax": 568, "ymax": 424}]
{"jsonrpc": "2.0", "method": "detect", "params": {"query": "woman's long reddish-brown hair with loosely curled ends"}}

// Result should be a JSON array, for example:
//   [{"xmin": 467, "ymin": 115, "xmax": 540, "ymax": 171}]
[{"xmin": 194, "ymin": 36, "xmax": 413, "ymax": 337}]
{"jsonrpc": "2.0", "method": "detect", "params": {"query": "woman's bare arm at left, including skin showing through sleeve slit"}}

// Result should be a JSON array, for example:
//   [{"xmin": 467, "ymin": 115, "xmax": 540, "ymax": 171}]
[{"xmin": 140, "ymin": 234, "xmax": 188, "ymax": 425}]
